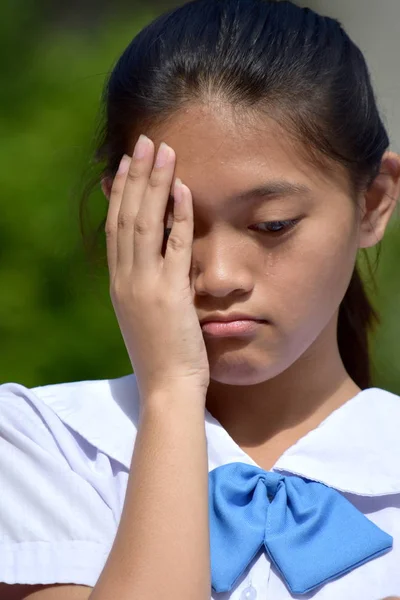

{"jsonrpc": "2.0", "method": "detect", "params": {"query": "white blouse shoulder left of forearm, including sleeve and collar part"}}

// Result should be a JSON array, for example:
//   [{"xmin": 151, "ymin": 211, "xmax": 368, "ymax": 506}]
[{"xmin": 0, "ymin": 376, "xmax": 138, "ymax": 586}]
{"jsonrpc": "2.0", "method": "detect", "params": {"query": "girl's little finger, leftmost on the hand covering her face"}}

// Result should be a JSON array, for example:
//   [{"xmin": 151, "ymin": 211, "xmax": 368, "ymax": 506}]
[{"xmin": 105, "ymin": 154, "xmax": 131, "ymax": 278}]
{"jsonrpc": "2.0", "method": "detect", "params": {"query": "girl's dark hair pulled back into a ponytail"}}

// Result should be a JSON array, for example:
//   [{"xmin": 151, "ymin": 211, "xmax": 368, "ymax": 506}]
[{"xmin": 80, "ymin": 0, "xmax": 389, "ymax": 389}]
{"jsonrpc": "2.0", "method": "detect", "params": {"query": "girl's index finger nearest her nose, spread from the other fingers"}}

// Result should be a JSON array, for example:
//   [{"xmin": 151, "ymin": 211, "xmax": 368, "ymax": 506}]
[{"xmin": 164, "ymin": 179, "xmax": 193, "ymax": 286}]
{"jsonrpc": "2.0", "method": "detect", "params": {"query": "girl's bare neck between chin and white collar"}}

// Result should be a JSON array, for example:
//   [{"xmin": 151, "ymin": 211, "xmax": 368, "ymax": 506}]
[{"xmin": 206, "ymin": 322, "xmax": 361, "ymax": 470}]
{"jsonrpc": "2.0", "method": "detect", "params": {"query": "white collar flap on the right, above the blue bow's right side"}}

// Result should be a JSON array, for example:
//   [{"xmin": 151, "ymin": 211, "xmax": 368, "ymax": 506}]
[{"xmin": 276, "ymin": 387, "xmax": 400, "ymax": 496}]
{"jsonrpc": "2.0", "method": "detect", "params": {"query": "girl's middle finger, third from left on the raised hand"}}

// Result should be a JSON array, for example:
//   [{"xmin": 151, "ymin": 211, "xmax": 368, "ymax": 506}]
[{"xmin": 133, "ymin": 142, "xmax": 176, "ymax": 271}]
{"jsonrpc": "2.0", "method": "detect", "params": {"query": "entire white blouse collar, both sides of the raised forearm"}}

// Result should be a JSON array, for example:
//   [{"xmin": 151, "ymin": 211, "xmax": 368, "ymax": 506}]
[{"xmin": 32, "ymin": 374, "xmax": 400, "ymax": 496}]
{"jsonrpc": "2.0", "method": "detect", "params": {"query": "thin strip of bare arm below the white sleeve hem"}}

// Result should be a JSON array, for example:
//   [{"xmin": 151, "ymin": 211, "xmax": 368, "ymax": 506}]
[{"xmin": 0, "ymin": 583, "xmax": 92, "ymax": 600}]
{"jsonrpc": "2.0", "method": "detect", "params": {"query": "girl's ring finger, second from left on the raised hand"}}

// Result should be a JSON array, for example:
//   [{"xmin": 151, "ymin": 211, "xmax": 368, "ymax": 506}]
[{"xmin": 117, "ymin": 136, "xmax": 154, "ymax": 271}]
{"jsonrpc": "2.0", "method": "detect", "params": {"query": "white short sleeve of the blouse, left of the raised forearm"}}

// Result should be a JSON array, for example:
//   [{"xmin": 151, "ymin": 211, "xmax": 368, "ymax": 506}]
[{"xmin": 0, "ymin": 384, "xmax": 117, "ymax": 587}]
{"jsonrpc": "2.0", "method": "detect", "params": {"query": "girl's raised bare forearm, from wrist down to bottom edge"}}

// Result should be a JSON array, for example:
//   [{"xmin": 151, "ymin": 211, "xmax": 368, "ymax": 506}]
[{"xmin": 90, "ymin": 391, "xmax": 211, "ymax": 600}]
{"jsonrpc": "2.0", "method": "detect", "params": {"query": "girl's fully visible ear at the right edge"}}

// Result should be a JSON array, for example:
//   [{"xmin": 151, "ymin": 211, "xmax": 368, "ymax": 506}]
[{"xmin": 359, "ymin": 152, "xmax": 400, "ymax": 248}]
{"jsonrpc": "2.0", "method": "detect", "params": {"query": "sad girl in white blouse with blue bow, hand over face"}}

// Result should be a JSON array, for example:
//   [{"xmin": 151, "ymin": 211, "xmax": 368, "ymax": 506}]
[{"xmin": 0, "ymin": 0, "xmax": 400, "ymax": 600}]
